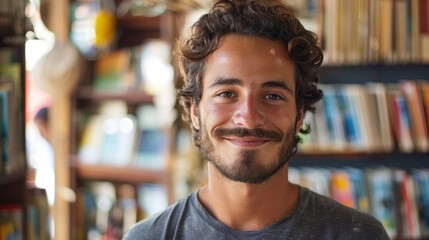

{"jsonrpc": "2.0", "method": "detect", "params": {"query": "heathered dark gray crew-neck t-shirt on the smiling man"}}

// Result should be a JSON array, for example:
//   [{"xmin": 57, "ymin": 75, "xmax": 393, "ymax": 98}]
[{"xmin": 123, "ymin": 187, "xmax": 389, "ymax": 240}]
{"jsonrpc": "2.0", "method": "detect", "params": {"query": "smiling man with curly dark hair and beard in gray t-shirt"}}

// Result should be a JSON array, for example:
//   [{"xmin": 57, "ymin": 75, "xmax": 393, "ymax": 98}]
[{"xmin": 124, "ymin": 0, "xmax": 388, "ymax": 240}]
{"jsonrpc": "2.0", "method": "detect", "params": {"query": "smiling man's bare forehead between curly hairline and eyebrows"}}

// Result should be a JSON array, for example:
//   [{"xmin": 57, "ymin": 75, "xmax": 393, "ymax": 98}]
[{"xmin": 203, "ymin": 34, "xmax": 295, "ymax": 89}]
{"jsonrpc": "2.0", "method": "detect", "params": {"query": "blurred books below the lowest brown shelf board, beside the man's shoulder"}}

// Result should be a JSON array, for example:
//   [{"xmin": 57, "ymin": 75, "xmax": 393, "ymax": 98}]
[{"xmin": 76, "ymin": 181, "xmax": 168, "ymax": 239}]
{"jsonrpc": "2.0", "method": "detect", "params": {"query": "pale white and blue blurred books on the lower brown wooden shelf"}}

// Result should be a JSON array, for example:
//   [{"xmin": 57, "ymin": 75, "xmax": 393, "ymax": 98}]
[{"xmin": 78, "ymin": 101, "xmax": 170, "ymax": 170}]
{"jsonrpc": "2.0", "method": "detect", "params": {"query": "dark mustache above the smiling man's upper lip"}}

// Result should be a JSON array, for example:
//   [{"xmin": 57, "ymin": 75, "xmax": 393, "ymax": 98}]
[{"xmin": 213, "ymin": 128, "xmax": 283, "ymax": 142}]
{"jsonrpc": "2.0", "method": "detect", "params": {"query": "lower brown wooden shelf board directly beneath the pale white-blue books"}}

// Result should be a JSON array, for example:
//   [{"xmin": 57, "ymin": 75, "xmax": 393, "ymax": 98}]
[{"xmin": 76, "ymin": 164, "xmax": 168, "ymax": 184}]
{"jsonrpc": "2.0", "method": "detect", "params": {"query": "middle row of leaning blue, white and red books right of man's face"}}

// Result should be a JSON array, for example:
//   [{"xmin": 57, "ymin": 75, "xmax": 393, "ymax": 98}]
[{"xmin": 300, "ymin": 80, "xmax": 429, "ymax": 153}]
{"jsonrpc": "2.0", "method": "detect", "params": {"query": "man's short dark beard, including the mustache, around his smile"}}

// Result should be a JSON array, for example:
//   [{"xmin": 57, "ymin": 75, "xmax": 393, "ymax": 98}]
[{"xmin": 199, "ymin": 121, "xmax": 296, "ymax": 184}]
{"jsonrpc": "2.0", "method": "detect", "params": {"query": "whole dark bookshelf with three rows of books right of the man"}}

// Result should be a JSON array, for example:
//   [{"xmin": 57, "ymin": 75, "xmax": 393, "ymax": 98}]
[{"xmin": 289, "ymin": 0, "xmax": 429, "ymax": 239}]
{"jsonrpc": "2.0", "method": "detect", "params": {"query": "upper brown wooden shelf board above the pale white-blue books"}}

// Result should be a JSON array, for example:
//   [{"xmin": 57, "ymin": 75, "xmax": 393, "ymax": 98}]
[{"xmin": 76, "ymin": 87, "xmax": 153, "ymax": 104}]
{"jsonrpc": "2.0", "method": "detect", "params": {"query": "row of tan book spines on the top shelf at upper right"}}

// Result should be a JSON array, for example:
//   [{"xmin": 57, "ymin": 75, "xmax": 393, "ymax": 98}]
[{"xmin": 311, "ymin": 0, "xmax": 429, "ymax": 65}]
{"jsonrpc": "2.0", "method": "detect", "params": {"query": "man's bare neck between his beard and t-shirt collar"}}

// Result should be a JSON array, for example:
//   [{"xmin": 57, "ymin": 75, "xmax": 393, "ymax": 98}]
[{"xmin": 198, "ymin": 164, "xmax": 299, "ymax": 231}]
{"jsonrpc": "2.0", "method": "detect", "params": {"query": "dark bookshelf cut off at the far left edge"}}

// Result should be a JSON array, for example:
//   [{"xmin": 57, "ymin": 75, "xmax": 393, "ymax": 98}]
[{"xmin": 0, "ymin": 1, "xmax": 31, "ymax": 239}]
